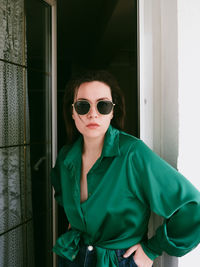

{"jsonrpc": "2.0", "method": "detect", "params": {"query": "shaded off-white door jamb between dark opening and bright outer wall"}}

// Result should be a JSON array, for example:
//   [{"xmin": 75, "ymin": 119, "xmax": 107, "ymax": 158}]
[{"xmin": 139, "ymin": 0, "xmax": 178, "ymax": 267}]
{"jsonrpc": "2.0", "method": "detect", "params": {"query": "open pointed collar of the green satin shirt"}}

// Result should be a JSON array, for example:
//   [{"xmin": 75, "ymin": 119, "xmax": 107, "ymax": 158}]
[{"xmin": 64, "ymin": 125, "xmax": 120, "ymax": 169}]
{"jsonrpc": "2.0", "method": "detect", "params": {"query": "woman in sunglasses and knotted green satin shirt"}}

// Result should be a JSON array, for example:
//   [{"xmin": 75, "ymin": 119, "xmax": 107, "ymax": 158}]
[{"xmin": 51, "ymin": 71, "xmax": 200, "ymax": 267}]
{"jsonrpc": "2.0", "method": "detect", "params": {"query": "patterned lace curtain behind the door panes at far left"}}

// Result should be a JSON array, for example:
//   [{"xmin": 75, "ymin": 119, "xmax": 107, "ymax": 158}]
[{"xmin": 0, "ymin": 0, "xmax": 33, "ymax": 267}]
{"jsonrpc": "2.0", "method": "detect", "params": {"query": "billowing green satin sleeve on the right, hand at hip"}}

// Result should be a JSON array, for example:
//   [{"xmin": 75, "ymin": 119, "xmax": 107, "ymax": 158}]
[{"xmin": 132, "ymin": 140, "xmax": 200, "ymax": 260}]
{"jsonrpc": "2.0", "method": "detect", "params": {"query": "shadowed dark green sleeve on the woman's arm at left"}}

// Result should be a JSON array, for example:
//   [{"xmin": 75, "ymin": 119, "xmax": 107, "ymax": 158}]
[{"xmin": 51, "ymin": 146, "xmax": 67, "ymax": 206}]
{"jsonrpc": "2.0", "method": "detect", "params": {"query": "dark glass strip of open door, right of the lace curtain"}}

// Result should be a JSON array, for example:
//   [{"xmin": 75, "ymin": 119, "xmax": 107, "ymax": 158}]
[{"xmin": 25, "ymin": 0, "xmax": 53, "ymax": 267}]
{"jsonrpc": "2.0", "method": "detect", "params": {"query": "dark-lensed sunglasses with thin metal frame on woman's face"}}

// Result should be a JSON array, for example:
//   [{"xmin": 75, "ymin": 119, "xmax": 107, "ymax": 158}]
[{"xmin": 72, "ymin": 100, "xmax": 115, "ymax": 115}]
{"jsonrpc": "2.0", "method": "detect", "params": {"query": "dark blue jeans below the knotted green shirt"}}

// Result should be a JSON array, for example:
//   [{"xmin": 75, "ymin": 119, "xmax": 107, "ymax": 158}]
[{"xmin": 58, "ymin": 246, "xmax": 137, "ymax": 267}]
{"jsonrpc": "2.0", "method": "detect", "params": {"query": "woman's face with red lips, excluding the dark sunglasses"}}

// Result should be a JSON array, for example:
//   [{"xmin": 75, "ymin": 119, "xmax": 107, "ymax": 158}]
[{"xmin": 72, "ymin": 81, "xmax": 113, "ymax": 138}]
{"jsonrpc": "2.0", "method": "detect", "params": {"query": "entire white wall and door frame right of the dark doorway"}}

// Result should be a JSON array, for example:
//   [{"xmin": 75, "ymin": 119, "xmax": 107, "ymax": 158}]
[{"xmin": 138, "ymin": 0, "xmax": 200, "ymax": 267}]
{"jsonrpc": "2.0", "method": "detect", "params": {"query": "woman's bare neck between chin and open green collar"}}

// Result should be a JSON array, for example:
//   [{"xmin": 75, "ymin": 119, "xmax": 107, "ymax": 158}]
[{"xmin": 83, "ymin": 136, "xmax": 104, "ymax": 157}]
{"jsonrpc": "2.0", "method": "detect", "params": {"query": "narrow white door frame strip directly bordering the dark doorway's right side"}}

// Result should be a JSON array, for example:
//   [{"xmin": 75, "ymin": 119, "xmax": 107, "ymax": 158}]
[{"xmin": 138, "ymin": 0, "xmax": 153, "ymax": 147}]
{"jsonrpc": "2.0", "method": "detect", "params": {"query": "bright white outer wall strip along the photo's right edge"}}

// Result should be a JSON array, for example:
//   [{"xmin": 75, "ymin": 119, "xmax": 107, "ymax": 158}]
[{"xmin": 178, "ymin": 0, "xmax": 200, "ymax": 267}]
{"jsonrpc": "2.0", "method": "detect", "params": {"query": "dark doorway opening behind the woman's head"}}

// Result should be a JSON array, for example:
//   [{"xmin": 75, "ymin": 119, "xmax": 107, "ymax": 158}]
[{"xmin": 57, "ymin": 0, "xmax": 138, "ymax": 238}]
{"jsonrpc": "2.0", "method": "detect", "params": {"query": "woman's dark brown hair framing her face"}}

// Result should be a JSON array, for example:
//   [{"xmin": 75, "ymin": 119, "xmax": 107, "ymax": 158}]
[{"xmin": 63, "ymin": 70, "xmax": 125, "ymax": 144}]
